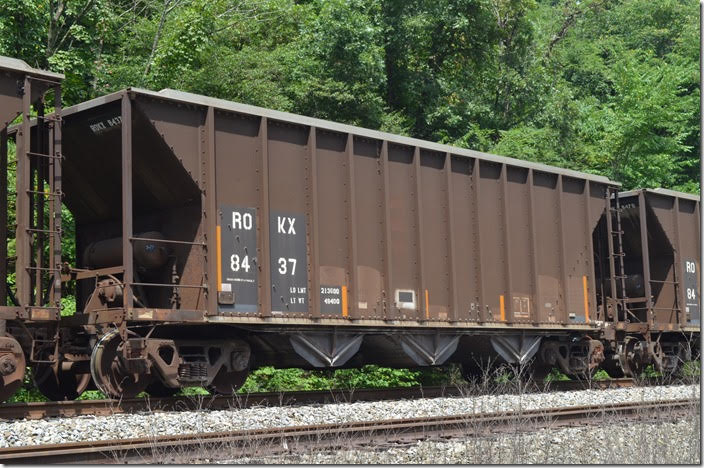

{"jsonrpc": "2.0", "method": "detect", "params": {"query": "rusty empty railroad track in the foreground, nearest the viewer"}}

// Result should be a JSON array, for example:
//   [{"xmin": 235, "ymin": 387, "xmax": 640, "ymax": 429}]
[{"xmin": 0, "ymin": 399, "xmax": 700, "ymax": 464}]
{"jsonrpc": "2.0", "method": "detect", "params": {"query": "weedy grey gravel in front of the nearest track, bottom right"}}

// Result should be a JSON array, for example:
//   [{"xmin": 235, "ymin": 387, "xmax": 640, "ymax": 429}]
[{"xmin": 230, "ymin": 415, "xmax": 700, "ymax": 465}]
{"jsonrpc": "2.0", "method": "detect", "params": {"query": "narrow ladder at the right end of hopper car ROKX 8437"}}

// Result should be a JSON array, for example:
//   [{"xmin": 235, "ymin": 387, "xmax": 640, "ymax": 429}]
[{"xmin": 606, "ymin": 187, "xmax": 628, "ymax": 322}]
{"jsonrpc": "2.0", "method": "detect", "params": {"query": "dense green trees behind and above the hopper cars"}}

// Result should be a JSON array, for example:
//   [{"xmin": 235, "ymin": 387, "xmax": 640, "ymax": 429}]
[{"xmin": 0, "ymin": 0, "xmax": 699, "ymax": 192}]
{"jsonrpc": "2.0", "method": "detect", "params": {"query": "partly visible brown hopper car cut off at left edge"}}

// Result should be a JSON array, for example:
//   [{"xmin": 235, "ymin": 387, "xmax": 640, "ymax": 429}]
[{"xmin": 0, "ymin": 57, "xmax": 63, "ymax": 401}]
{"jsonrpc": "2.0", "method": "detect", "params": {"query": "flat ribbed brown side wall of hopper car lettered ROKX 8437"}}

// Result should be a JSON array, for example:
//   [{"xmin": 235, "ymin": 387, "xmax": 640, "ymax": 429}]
[{"xmin": 190, "ymin": 104, "xmax": 606, "ymax": 324}]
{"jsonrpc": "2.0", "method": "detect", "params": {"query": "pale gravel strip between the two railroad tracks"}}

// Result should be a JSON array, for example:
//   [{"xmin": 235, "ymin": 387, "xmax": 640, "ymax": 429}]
[{"xmin": 0, "ymin": 385, "xmax": 699, "ymax": 447}]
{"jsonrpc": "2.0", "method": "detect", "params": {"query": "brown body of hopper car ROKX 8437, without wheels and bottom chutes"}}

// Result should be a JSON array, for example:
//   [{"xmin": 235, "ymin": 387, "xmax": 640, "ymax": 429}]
[{"xmin": 51, "ymin": 90, "xmax": 628, "ymax": 327}]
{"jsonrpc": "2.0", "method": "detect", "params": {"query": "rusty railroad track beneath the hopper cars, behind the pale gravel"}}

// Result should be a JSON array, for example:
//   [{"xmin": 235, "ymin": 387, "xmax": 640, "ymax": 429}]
[{"xmin": 0, "ymin": 379, "xmax": 635, "ymax": 420}]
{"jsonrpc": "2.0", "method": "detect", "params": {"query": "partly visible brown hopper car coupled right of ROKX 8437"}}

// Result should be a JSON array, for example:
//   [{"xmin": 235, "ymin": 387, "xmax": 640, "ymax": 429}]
[{"xmin": 595, "ymin": 189, "xmax": 701, "ymax": 376}]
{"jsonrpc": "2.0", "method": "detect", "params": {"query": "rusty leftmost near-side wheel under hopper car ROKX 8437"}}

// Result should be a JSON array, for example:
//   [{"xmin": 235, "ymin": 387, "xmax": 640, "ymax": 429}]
[{"xmin": 90, "ymin": 330, "xmax": 150, "ymax": 399}]
